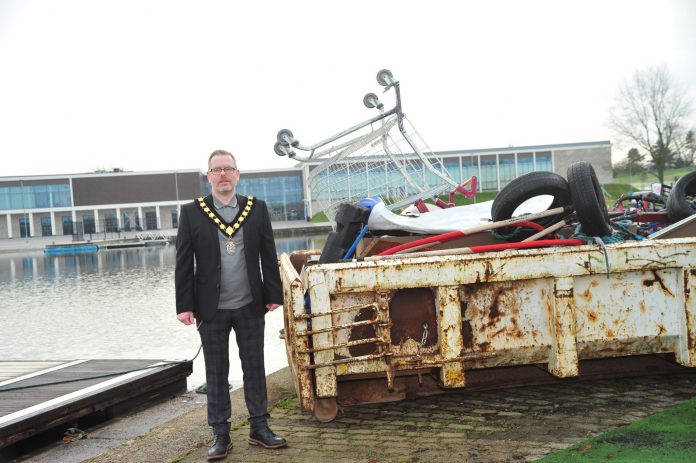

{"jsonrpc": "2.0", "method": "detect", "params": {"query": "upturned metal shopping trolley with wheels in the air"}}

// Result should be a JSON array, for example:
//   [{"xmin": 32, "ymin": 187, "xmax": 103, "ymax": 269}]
[{"xmin": 274, "ymin": 69, "xmax": 458, "ymax": 220}]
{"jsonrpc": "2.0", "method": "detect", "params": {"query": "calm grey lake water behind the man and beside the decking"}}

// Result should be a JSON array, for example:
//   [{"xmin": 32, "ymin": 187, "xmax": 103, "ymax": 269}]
[{"xmin": 0, "ymin": 235, "xmax": 326, "ymax": 388}]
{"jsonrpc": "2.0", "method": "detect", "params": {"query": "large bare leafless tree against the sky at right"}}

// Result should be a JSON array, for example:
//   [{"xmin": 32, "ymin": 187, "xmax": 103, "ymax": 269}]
[{"xmin": 609, "ymin": 66, "xmax": 690, "ymax": 183}]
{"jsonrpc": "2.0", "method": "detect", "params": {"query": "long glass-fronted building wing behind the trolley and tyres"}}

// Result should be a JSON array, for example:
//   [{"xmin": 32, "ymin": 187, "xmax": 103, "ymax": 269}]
[{"xmin": 303, "ymin": 141, "xmax": 613, "ymax": 218}]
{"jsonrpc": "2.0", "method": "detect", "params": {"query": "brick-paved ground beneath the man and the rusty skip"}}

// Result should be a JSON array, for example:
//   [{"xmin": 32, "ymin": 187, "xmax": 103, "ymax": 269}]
[{"xmin": 21, "ymin": 369, "xmax": 696, "ymax": 463}]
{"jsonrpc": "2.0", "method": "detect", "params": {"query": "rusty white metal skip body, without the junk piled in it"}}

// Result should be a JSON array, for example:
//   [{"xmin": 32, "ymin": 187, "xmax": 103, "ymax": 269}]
[{"xmin": 280, "ymin": 238, "xmax": 696, "ymax": 421}]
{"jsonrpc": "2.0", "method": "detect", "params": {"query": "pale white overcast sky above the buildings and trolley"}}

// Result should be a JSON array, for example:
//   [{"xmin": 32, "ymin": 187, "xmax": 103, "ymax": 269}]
[{"xmin": 0, "ymin": 0, "xmax": 696, "ymax": 176}]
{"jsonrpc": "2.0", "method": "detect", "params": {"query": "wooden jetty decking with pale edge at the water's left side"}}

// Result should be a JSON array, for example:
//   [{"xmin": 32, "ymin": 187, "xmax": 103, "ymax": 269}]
[{"xmin": 0, "ymin": 359, "xmax": 192, "ymax": 448}]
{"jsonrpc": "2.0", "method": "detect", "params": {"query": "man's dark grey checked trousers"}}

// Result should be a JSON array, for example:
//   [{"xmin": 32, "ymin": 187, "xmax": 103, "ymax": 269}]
[{"xmin": 198, "ymin": 303, "xmax": 268, "ymax": 435}]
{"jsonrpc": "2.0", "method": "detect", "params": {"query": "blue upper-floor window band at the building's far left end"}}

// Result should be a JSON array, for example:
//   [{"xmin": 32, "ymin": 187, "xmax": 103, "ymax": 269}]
[{"xmin": 0, "ymin": 183, "xmax": 72, "ymax": 211}]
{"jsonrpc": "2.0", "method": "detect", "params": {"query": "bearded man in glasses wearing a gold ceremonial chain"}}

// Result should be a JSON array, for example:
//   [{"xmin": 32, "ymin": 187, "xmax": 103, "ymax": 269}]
[{"xmin": 175, "ymin": 150, "xmax": 287, "ymax": 460}]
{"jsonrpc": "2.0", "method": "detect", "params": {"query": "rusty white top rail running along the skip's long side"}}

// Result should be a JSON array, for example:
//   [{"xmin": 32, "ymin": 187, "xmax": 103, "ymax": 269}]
[{"xmin": 314, "ymin": 238, "xmax": 696, "ymax": 294}]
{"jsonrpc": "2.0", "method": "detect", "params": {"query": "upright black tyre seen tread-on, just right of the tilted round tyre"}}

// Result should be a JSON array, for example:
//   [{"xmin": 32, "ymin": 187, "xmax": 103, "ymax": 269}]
[{"xmin": 566, "ymin": 161, "xmax": 612, "ymax": 236}]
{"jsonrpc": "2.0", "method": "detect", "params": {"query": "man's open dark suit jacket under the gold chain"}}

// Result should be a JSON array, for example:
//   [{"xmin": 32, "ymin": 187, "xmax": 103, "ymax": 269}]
[{"xmin": 174, "ymin": 195, "xmax": 283, "ymax": 320}]
